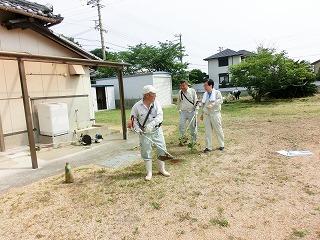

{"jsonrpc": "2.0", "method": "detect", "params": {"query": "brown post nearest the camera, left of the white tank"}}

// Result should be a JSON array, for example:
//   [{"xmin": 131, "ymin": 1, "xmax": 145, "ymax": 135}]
[{"xmin": 18, "ymin": 58, "xmax": 38, "ymax": 169}]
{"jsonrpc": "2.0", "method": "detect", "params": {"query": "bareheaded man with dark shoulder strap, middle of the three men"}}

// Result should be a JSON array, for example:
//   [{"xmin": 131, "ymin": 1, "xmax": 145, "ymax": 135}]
[{"xmin": 177, "ymin": 81, "xmax": 198, "ymax": 146}]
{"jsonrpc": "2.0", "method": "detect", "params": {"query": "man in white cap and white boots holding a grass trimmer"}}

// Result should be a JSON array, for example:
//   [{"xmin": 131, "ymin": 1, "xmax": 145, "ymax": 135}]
[{"xmin": 131, "ymin": 85, "xmax": 172, "ymax": 181}]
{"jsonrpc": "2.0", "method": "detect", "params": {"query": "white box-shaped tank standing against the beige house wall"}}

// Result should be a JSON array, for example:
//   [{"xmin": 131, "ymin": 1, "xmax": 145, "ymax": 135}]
[{"xmin": 38, "ymin": 103, "xmax": 69, "ymax": 136}]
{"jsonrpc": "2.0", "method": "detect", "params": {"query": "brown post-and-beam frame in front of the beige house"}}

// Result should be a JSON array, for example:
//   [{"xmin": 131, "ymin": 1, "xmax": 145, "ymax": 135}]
[{"xmin": 0, "ymin": 51, "xmax": 130, "ymax": 169}]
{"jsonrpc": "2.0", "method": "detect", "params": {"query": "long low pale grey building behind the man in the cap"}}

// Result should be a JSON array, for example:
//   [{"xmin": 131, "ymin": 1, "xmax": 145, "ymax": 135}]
[{"xmin": 93, "ymin": 72, "xmax": 172, "ymax": 108}]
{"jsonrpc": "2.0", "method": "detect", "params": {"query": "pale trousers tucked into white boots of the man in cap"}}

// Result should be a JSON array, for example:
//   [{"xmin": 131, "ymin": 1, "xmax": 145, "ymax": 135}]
[{"xmin": 139, "ymin": 127, "xmax": 167, "ymax": 161}]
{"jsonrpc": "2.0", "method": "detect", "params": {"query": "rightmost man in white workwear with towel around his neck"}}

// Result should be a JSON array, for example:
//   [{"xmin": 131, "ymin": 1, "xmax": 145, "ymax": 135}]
[{"xmin": 200, "ymin": 79, "xmax": 224, "ymax": 153}]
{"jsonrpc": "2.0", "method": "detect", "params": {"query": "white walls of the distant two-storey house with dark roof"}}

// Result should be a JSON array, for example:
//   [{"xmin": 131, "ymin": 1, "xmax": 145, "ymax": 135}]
[{"xmin": 208, "ymin": 56, "xmax": 241, "ymax": 89}]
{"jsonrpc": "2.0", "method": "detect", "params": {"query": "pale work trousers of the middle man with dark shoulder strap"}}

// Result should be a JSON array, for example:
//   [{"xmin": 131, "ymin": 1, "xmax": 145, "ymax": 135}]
[{"xmin": 179, "ymin": 111, "xmax": 198, "ymax": 142}]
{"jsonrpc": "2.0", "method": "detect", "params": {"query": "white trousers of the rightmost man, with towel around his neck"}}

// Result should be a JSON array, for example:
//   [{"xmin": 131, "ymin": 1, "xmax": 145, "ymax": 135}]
[{"xmin": 203, "ymin": 111, "xmax": 224, "ymax": 150}]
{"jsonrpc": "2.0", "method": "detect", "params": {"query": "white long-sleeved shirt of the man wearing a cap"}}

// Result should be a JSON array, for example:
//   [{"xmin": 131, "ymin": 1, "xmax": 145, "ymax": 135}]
[{"xmin": 131, "ymin": 99, "xmax": 163, "ymax": 130}]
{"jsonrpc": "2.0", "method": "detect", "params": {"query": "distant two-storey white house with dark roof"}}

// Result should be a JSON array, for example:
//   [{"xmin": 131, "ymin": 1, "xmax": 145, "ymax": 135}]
[{"xmin": 204, "ymin": 49, "xmax": 252, "ymax": 89}]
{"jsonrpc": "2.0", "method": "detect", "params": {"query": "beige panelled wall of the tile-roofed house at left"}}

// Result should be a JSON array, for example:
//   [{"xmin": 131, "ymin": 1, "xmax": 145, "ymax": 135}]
[{"xmin": 0, "ymin": 26, "xmax": 94, "ymax": 148}]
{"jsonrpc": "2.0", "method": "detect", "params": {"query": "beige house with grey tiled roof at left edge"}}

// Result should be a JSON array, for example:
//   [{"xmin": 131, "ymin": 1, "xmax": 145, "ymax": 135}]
[{"xmin": 0, "ymin": 0, "xmax": 102, "ymax": 148}]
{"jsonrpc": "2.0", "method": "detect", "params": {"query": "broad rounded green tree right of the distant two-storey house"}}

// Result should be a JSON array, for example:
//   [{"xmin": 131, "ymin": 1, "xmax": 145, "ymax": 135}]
[{"xmin": 230, "ymin": 47, "xmax": 315, "ymax": 101}]
